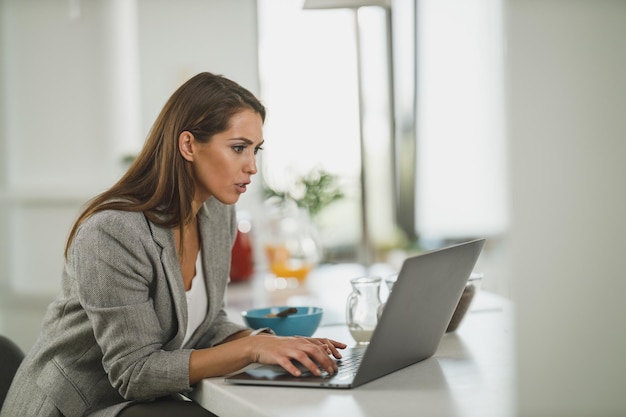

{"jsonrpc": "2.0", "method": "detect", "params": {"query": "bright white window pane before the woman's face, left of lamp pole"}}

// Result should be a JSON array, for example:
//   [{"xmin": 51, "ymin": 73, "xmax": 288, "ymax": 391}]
[{"xmin": 258, "ymin": 0, "xmax": 360, "ymax": 254}]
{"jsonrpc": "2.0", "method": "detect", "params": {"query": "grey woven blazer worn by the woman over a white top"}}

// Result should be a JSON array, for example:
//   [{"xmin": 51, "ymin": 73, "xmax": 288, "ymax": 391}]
[{"xmin": 0, "ymin": 198, "xmax": 249, "ymax": 417}]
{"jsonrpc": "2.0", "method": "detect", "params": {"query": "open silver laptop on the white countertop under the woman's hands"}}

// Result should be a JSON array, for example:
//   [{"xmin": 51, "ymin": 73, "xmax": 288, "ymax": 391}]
[{"xmin": 225, "ymin": 239, "xmax": 485, "ymax": 388}]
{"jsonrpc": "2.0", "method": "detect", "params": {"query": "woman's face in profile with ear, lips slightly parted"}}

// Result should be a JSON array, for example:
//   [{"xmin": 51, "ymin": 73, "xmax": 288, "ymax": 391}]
[{"xmin": 179, "ymin": 109, "xmax": 263, "ymax": 205}]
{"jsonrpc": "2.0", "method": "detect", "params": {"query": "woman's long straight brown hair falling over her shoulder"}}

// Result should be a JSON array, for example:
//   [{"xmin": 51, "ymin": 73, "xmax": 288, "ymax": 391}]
[{"xmin": 65, "ymin": 72, "xmax": 265, "ymax": 256}]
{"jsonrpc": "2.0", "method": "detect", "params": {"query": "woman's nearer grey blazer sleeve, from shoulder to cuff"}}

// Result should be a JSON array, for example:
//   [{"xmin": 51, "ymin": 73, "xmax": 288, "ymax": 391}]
[{"xmin": 69, "ymin": 211, "xmax": 191, "ymax": 400}]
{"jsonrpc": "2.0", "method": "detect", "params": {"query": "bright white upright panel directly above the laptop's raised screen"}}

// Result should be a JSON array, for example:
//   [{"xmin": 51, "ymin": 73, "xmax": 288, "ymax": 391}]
[{"xmin": 416, "ymin": 0, "xmax": 508, "ymax": 241}]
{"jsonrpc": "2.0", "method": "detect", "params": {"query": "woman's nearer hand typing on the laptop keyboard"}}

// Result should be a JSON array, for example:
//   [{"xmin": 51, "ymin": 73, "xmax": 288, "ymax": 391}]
[{"xmin": 249, "ymin": 333, "xmax": 346, "ymax": 376}]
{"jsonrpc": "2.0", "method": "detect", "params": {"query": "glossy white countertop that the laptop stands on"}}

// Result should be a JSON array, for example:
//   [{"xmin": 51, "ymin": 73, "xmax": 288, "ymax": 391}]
[{"xmin": 192, "ymin": 292, "xmax": 515, "ymax": 417}]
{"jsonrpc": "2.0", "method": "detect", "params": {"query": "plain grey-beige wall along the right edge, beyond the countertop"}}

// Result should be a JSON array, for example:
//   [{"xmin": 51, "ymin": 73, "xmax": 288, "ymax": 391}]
[{"xmin": 506, "ymin": 0, "xmax": 626, "ymax": 417}]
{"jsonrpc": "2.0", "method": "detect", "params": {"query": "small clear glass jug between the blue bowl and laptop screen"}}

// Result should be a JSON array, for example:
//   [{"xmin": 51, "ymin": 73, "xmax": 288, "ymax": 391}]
[{"xmin": 346, "ymin": 276, "xmax": 383, "ymax": 345}]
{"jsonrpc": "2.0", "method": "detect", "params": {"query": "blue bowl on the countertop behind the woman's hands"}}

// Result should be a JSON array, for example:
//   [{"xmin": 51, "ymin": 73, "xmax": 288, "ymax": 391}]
[{"xmin": 241, "ymin": 306, "xmax": 324, "ymax": 337}]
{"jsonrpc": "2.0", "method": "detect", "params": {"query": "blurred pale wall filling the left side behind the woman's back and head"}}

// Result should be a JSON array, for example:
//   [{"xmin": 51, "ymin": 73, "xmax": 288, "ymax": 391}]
[{"xmin": 0, "ymin": 0, "xmax": 259, "ymax": 297}]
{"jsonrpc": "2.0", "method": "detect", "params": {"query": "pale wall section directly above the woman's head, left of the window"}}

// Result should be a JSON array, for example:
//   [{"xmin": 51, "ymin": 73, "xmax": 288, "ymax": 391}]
[{"xmin": 138, "ymin": 0, "xmax": 259, "ymax": 138}]
